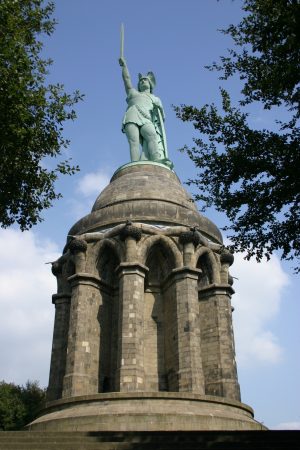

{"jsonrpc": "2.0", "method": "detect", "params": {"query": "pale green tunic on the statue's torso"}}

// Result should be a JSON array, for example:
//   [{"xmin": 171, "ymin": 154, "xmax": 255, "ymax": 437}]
[{"xmin": 122, "ymin": 88, "xmax": 160, "ymax": 132}]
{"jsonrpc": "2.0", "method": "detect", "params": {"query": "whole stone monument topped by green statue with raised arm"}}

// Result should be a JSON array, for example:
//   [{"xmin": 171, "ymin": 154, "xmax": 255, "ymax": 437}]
[{"xmin": 29, "ymin": 44, "xmax": 264, "ymax": 432}]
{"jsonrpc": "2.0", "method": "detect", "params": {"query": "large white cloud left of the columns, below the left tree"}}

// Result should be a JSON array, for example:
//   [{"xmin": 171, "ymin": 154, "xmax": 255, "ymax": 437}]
[{"xmin": 0, "ymin": 229, "xmax": 59, "ymax": 385}]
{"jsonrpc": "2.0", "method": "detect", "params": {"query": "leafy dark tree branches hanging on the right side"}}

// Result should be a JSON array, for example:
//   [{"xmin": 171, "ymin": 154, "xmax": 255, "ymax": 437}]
[{"xmin": 175, "ymin": 0, "xmax": 300, "ymax": 272}]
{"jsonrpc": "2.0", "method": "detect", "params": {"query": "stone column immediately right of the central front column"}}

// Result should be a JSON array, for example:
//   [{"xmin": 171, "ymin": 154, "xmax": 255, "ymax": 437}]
[{"xmin": 166, "ymin": 267, "xmax": 204, "ymax": 394}]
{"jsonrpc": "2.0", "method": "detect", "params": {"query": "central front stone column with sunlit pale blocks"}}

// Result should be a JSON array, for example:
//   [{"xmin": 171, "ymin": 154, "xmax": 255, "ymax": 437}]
[{"xmin": 117, "ymin": 262, "xmax": 148, "ymax": 392}]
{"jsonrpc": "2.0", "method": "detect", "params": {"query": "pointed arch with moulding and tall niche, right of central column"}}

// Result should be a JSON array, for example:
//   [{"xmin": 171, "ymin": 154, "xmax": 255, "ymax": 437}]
[{"xmin": 139, "ymin": 235, "xmax": 183, "ymax": 391}]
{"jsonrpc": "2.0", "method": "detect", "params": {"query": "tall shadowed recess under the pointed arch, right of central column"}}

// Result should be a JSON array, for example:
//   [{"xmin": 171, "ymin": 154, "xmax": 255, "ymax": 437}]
[{"xmin": 144, "ymin": 240, "xmax": 174, "ymax": 391}]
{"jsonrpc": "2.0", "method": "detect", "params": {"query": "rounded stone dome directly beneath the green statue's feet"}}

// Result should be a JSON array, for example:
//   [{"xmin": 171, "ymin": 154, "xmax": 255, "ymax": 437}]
[{"xmin": 69, "ymin": 162, "xmax": 222, "ymax": 242}]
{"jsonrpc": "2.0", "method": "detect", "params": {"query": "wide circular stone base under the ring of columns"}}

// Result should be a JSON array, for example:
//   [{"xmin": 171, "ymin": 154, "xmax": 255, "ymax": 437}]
[{"xmin": 27, "ymin": 392, "xmax": 266, "ymax": 431}]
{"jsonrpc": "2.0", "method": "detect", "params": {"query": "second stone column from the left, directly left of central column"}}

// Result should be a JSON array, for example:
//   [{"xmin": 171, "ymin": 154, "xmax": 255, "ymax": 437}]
[{"xmin": 63, "ymin": 273, "xmax": 101, "ymax": 397}]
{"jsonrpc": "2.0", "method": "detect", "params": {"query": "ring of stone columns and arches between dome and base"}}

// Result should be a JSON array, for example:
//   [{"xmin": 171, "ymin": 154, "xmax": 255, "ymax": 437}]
[{"xmin": 48, "ymin": 222, "xmax": 240, "ymax": 400}]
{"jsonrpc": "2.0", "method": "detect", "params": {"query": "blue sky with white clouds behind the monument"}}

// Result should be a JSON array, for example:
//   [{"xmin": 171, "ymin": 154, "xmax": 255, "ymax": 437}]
[{"xmin": 0, "ymin": 0, "xmax": 300, "ymax": 429}]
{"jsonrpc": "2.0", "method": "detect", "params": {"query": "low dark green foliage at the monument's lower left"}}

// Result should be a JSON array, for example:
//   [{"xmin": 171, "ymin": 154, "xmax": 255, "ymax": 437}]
[{"xmin": 0, "ymin": 381, "xmax": 46, "ymax": 431}]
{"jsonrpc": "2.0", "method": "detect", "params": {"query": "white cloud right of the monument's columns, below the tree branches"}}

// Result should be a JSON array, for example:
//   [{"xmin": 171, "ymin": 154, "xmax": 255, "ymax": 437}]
[{"xmin": 231, "ymin": 253, "xmax": 289, "ymax": 367}]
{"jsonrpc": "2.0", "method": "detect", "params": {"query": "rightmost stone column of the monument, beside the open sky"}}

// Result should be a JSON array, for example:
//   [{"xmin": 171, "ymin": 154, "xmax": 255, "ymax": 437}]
[{"xmin": 199, "ymin": 284, "xmax": 240, "ymax": 401}]
